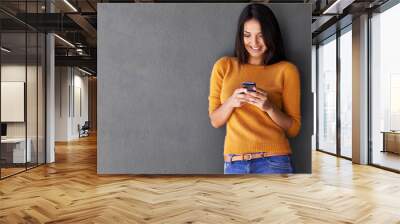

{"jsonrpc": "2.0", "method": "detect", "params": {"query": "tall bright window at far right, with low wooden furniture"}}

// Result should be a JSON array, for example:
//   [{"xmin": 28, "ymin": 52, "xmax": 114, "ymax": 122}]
[{"xmin": 370, "ymin": 1, "xmax": 400, "ymax": 170}]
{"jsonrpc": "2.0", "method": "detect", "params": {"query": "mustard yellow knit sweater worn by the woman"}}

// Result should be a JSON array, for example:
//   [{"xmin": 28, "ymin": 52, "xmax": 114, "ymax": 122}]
[{"xmin": 208, "ymin": 57, "xmax": 301, "ymax": 155}]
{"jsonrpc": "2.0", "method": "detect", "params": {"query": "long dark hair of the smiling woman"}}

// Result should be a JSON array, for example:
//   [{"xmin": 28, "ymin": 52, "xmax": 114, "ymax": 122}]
[{"xmin": 235, "ymin": 3, "xmax": 286, "ymax": 65}]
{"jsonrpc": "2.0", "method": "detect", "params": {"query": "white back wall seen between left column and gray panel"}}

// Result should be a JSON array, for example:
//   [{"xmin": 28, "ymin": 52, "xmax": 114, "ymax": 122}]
[{"xmin": 55, "ymin": 67, "xmax": 88, "ymax": 141}]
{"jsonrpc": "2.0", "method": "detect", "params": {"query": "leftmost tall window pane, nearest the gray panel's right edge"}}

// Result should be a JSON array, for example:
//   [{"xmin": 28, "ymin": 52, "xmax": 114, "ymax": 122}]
[{"xmin": 318, "ymin": 39, "xmax": 336, "ymax": 153}]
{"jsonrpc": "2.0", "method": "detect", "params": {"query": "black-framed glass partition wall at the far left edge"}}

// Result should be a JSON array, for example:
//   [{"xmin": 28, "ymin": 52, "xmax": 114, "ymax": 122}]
[{"xmin": 0, "ymin": 1, "xmax": 46, "ymax": 179}]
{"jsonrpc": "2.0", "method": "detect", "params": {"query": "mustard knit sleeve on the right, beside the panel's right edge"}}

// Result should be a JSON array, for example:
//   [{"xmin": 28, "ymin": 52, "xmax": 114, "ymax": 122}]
[{"xmin": 282, "ymin": 63, "xmax": 301, "ymax": 137}]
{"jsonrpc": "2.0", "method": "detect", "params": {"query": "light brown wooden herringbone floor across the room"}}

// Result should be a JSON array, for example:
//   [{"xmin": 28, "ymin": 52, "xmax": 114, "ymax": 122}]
[{"xmin": 0, "ymin": 134, "xmax": 400, "ymax": 224}]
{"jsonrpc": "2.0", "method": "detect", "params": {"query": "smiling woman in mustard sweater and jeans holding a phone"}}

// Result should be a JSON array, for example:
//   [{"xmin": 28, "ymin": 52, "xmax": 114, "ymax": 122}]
[{"xmin": 209, "ymin": 4, "xmax": 300, "ymax": 174}]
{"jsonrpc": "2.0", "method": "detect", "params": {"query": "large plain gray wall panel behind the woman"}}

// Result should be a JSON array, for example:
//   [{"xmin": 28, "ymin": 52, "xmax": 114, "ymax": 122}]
[{"xmin": 97, "ymin": 3, "xmax": 313, "ymax": 174}]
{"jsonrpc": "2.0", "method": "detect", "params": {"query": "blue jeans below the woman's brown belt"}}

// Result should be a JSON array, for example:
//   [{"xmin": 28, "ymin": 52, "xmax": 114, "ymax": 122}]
[{"xmin": 224, "ymin": 155, "xmax": 293, "ymax": 174}]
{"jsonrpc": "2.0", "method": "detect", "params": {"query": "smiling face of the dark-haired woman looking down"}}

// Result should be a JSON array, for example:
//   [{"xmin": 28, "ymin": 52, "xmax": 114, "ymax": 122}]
[{"xmin": 243, "ymin": 19, "xmax": 267, "ymax": 64}]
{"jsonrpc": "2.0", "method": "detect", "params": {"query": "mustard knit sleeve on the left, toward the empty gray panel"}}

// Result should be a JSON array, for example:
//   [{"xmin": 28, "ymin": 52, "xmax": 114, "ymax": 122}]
[{"xmin": 208, "ymin": 57, "xmax": 227, "ymax": 114}]
